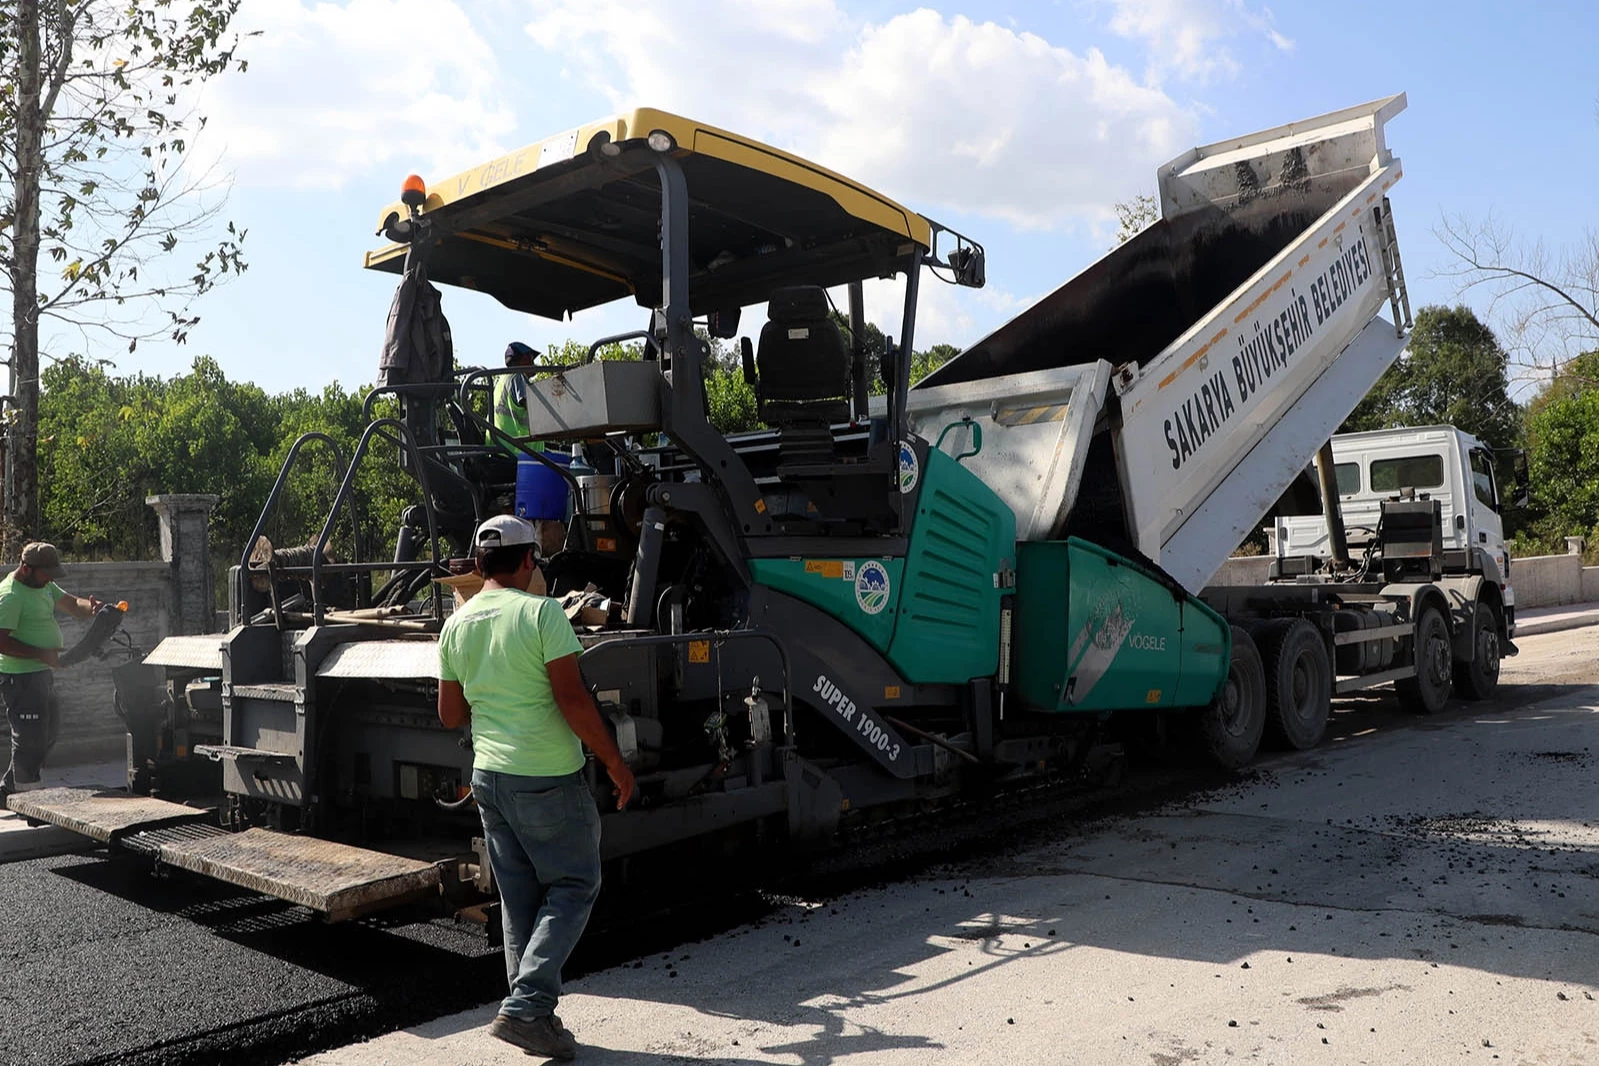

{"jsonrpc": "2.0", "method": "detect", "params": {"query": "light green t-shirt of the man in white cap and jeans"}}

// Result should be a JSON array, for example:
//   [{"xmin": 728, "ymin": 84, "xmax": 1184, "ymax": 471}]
[{"xmin": 438, "ymin": 588, "xmax": 584, "ymax": 777}]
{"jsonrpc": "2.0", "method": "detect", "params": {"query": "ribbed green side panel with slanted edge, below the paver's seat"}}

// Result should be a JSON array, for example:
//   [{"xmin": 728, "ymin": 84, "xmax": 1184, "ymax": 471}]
[{"xmin": 889, "ymin": 449, "xmax": 1017, "ymax": 684}]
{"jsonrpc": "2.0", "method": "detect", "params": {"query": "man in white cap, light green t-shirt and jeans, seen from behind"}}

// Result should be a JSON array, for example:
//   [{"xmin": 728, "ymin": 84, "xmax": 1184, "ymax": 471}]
[{"xmin": 438, "ymin": 515, "xmax": 633, "ymax": 1060}]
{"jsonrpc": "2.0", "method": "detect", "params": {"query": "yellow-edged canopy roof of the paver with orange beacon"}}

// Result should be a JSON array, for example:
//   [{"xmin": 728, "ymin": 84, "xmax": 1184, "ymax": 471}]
[{"xmin": 366, "ymin": 109, "xmax": 932, "ymax": 326}]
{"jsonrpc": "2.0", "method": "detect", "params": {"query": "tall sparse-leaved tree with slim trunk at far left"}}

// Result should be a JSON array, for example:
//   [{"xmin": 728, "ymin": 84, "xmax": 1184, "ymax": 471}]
[{"xmin": 0, "ymin": 0, "xmax": 245, "ymax": 550}]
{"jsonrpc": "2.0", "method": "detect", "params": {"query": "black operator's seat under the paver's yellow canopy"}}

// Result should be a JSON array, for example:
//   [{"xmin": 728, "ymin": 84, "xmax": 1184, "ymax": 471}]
[{"xmin": 755, "ymin": 292, "xmax": 849, "ymax": 427}]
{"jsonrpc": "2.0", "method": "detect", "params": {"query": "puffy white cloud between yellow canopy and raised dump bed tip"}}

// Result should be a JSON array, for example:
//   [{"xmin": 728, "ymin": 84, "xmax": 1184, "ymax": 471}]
[{"xmin": 814, "ymin": 10, "xmax": 1193, "ymax": 225}]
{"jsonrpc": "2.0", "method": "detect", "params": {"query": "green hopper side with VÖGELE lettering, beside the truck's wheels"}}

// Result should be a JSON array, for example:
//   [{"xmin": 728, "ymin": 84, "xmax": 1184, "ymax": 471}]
[{"xmin": 1012, "ymin": 539, "xmax": 1231, "ymax": 711}]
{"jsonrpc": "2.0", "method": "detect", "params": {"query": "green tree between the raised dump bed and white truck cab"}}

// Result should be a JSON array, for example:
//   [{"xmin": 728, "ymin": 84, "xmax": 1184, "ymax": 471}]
[{"xmin": 1343, "ymin": 305, "xmax": 1521, "ymax": 447}]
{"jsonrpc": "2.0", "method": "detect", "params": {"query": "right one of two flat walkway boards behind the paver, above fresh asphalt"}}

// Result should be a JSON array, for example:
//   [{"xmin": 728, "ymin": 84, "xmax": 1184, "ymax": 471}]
[{"xmin": 160, "ymin": 829, "xmax": 440, "ymax": 921}]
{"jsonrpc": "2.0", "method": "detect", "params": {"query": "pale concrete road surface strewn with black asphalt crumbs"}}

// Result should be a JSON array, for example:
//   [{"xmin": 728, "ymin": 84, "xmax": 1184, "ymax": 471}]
[{"xmin": 307, "ymin": 628, "xmax": 1599, "ymax": 1066}]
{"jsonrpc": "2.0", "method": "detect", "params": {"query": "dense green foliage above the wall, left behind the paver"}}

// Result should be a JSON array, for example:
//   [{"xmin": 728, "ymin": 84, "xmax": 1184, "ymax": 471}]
[{"xmin": 40, "ymin": 358, "xmax": 416, "ymax": 566}]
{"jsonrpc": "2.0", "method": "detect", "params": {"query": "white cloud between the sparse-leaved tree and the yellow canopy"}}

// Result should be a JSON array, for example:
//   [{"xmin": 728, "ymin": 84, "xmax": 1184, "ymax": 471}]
[{"xmin": 203, "ymin": 0, "xmax": 516, "ymax": 189}]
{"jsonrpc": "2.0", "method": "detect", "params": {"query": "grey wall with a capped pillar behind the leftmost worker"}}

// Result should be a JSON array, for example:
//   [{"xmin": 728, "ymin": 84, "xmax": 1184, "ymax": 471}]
[{"xmin": 0, "ymin": 495, "xmax": 216, "ymax": 767}]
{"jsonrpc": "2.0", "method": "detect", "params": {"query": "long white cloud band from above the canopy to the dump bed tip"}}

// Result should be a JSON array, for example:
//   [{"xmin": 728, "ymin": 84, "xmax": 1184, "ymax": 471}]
[{"xmin": 528, "ymin": 0, "xmax": 1194, "ymax": 227}]
